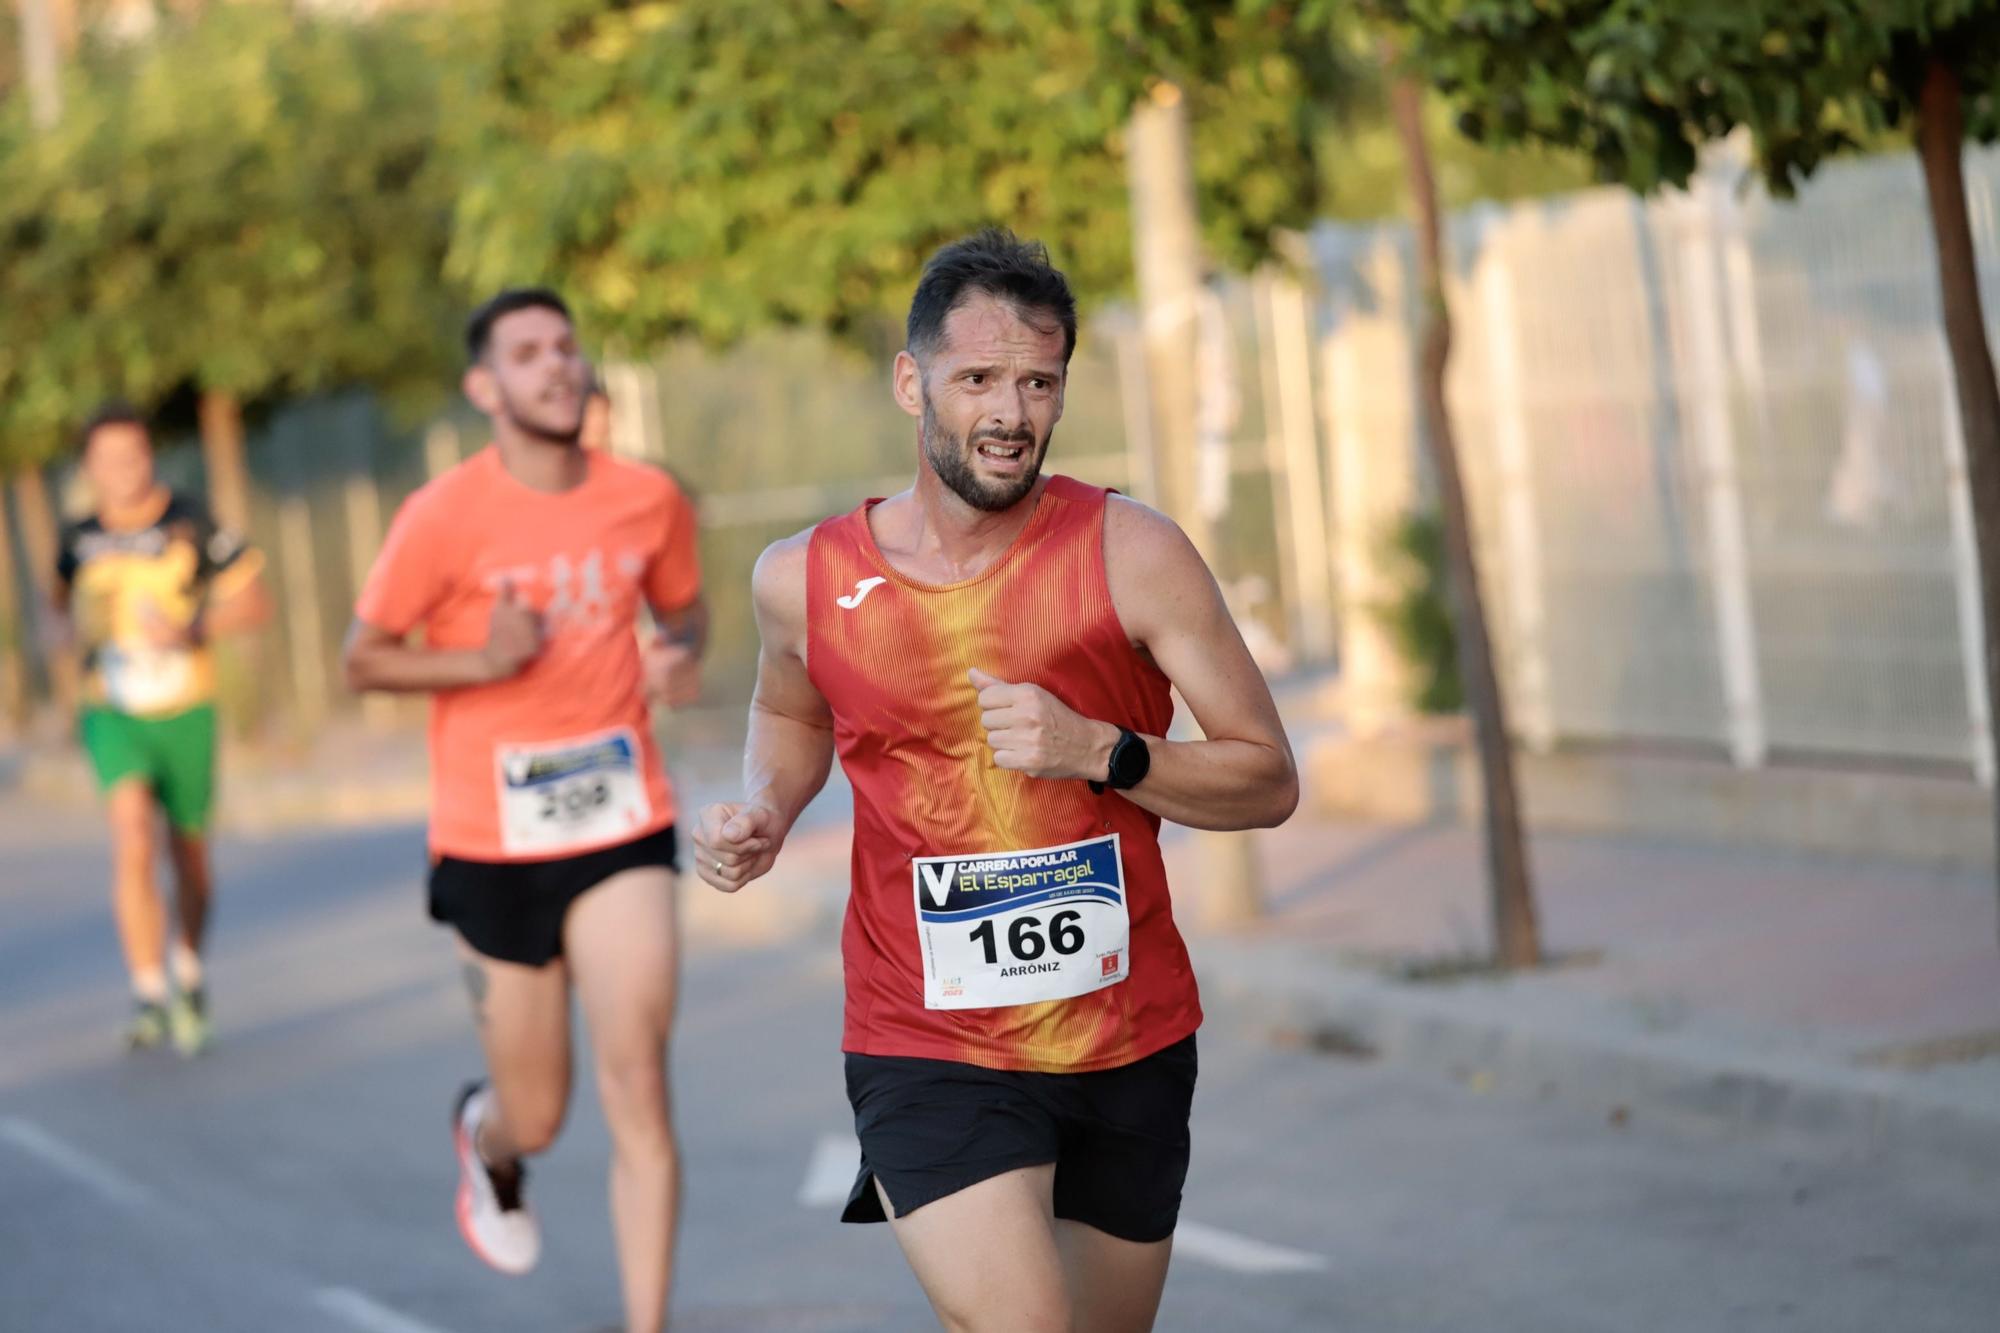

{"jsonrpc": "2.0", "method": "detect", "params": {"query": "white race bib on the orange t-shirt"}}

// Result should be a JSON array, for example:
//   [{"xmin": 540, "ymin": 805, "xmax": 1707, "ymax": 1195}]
[{"xmin": 498, "ymin": 727, "xmax": 652, "ymax": 857}]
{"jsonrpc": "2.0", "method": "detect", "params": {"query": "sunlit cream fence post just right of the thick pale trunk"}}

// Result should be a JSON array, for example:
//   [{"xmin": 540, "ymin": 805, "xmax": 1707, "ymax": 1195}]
[{"xmin": 1258, "ymin": 274, "xmax": 1334, "ymax": 662}]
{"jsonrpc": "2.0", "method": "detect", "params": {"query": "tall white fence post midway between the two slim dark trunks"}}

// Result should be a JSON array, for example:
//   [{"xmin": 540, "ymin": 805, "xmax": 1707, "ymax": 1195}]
[{"xmin": 1670, "ymin": 176, "xmax": 1768, "ymax": 769}]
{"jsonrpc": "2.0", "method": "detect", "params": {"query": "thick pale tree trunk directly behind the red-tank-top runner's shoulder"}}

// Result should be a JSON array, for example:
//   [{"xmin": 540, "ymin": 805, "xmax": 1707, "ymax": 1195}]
[{"xmin": 1126, "ymin": 82, "xmax": 1264, "ymax": 925}]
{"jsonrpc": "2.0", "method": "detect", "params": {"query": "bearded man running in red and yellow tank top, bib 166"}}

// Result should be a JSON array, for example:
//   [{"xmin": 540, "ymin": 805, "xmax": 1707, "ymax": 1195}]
[{"xmin": 694, "ymin": 230, "xmax": 1298, "ymax": 1333}]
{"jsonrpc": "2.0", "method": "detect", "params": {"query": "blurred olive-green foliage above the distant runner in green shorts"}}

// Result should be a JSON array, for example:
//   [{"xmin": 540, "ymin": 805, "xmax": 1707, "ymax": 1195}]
[{"xmin": 0, "ymin": 6, "xmax": 456, "ymax": 460}]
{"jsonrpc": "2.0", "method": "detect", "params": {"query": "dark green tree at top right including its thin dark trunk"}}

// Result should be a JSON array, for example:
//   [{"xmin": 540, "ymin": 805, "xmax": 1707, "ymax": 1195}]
[{"xmin": 1382, "ymin": 0, "xmax": 2000, "ymax": 928}]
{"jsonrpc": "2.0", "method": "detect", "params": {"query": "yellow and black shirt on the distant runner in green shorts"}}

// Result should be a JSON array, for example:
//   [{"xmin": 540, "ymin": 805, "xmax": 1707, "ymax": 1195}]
[{"xmin": 56, "ymin": 490, "xmax": 264, "ymax": 717}]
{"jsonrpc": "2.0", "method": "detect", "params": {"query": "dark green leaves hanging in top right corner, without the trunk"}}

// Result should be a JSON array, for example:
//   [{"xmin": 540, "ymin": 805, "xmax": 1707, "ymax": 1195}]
[{"xmin": 1376, "ymin": 0, "xmax": 2000, "ymax": 196}]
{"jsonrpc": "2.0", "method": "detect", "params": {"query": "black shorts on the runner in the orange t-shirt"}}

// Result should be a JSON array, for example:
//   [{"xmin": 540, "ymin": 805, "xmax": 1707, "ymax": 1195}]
[{"xmin": 430, "ymin": 825, "xmax": 680, "ymax": 967}]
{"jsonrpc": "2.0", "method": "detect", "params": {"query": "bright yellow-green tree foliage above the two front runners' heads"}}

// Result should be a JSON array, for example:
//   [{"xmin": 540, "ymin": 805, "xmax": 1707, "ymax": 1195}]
[{"xmin": 440, "ymin": 0, "xmax": 1338, "ymax": 346}]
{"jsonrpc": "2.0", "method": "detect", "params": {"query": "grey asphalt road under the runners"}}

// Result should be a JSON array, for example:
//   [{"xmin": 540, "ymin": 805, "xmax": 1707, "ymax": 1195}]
[{"xmin": 0, "ymin": 797, "xmax": 2000, "ymax": 1333}]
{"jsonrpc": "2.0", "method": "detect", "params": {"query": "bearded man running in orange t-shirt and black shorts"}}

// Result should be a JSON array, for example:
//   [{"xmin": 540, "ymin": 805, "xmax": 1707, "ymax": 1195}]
[{"xmin": 346, "ymin": 288, "xmax": 706, "ymax": 1333}]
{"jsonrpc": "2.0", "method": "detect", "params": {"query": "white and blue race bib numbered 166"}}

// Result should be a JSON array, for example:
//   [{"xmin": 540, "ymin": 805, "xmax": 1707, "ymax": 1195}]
[{"xmin": 912, "ymin": 833, "xmax": 1132, "ymax": 1009}]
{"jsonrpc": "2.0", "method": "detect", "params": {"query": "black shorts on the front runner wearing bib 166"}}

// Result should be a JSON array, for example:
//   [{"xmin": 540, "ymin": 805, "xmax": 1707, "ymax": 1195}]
[{"xmin": 840, "ymin": 1035, "xmax": 1196, "ymax": 1243}]
